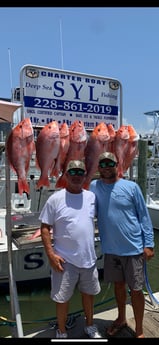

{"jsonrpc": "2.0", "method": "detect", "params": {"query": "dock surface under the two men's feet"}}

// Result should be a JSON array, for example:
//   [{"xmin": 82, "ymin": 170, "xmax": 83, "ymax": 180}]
[{"xmin": 5, "ymin": 292, "xmax": 159, "ymax": 338}]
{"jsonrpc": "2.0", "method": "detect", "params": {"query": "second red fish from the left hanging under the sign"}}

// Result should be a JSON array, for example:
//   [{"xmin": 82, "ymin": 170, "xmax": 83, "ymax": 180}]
[{"xmin": 36, "ymin": 121, "xmax": 60, "ymax": 188}]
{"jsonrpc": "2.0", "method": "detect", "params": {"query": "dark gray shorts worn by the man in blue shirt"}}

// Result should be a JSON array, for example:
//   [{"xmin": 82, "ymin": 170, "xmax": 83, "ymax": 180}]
[{"xmin": 104, "ymin": 254, "xmax": 145, "ymax": 291}]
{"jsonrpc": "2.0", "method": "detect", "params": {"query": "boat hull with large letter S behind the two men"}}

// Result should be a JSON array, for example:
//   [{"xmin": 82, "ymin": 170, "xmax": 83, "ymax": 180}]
[{"xmin": 0, "ymin": 210, "xmax": 103, "ymax": 282}]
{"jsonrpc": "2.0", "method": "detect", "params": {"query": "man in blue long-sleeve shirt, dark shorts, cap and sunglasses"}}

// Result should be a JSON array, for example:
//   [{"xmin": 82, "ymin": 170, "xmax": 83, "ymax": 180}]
[{"xmin": 90, "ymin": 152, "xmax": 154, "ymax": 338}]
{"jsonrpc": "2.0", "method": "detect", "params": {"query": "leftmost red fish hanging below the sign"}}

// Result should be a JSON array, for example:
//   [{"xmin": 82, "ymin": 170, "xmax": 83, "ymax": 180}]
[{"xmin": 6, "ymin": 118, "xmax": 35, "ymax": 195}]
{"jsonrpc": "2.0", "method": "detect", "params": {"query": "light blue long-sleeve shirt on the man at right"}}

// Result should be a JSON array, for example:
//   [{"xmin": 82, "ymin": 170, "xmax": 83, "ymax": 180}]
[{"xmin": 90, "ymin": 178, "xmax": 154, "ymax": 256}]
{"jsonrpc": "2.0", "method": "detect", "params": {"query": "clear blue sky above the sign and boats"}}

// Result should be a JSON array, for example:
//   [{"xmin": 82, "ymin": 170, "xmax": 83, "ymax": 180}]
[{"xmin": 0, "ymin": 7, "xmax": 159, "ymax": 134}]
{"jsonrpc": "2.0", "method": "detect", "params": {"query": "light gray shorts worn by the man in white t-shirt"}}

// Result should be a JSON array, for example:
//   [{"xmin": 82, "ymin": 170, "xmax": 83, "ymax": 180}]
[{"xmin": 51, "ymin": 262, "xmax": 101, "ymax": 303}]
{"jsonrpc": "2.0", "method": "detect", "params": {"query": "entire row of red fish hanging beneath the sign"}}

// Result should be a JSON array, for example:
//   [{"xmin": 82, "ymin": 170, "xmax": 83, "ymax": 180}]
[{"xmin": 6, "ymin": 118, "xmax": 139, "ymax": 194}]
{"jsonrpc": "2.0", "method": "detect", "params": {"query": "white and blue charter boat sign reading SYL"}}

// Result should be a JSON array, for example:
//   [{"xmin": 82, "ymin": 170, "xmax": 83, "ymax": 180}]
[{"xmin": 20, "ymin": 65, "xmax": 121, "ymax": 129}]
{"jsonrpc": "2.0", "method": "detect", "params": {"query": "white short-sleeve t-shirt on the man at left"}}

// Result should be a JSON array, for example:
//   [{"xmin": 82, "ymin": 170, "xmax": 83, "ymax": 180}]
[{"xmin": 39, "ymin": 189, "xmax": 97, "ymax": 268}]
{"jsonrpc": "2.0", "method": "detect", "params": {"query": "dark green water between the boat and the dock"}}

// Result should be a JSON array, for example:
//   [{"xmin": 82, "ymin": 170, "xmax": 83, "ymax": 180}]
[{"xmin": 0, "ymin": 230, "xmax": 159, "ymax": 337}]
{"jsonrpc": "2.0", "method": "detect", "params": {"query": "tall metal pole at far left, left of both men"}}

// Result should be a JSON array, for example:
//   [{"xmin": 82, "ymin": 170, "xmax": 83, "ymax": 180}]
[{"xmin": 5, "ymin": 129, "xmax": 23, "ymax": 338}]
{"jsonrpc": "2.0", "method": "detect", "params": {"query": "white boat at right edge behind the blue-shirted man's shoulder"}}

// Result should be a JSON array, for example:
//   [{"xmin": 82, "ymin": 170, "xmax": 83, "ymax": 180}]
[{"xmin": 121, "ymin": 110, "xmax": 159, "ymax": 230}]
